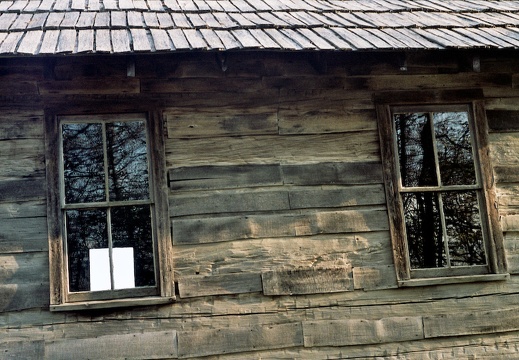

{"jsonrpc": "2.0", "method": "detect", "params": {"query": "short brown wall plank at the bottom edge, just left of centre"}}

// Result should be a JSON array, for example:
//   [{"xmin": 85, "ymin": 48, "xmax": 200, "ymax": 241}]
[{"xmin": 178, "ymin": 323, "xmax": 303, "ymax": 358}]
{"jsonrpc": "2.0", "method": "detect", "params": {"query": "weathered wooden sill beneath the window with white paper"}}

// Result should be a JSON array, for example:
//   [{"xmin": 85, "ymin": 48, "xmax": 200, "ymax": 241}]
[{"xmin": 50, "ymin": 296, "xmax": 176, "ymax": 311}]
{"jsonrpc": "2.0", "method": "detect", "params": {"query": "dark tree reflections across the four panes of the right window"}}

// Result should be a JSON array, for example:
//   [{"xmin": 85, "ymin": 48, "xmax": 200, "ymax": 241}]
[{"xmin": 394, "ymin": 112, "xmax": 486, "ymax": 268}]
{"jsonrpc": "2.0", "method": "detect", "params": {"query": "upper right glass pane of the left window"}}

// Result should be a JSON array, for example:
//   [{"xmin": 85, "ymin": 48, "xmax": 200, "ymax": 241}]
[{"xmin": 106, "ymin": 121, "xmax": 148, "ymax": 201}]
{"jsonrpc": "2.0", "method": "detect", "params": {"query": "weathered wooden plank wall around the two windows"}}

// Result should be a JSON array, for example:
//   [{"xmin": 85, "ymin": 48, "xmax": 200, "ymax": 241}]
[{"xmin": 0, "ymin": 52, "xmax": 519, "ymax": 360}]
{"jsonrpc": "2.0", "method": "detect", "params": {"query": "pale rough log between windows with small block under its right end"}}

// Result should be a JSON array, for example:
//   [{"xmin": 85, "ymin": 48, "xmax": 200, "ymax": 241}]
[{"xmin": 174, "ymin": 231, "xmax": 396, "ymax": 278}]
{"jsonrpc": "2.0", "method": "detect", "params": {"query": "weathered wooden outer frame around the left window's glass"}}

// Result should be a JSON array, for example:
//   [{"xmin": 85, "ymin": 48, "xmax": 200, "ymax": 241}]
[{"xmin": 45, "ymin": 107, "xmax": 175, "ymax": 311}]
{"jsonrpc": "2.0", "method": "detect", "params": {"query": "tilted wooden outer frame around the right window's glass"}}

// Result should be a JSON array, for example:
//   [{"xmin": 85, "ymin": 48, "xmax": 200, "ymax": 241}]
[{"xmin": 375, "ymin": 90, "xmax": 509, "ymax": 286}]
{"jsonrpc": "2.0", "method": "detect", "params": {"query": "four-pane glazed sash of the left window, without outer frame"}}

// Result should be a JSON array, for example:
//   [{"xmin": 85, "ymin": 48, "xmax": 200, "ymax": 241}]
[{"xmin": 60, "ymin": 116, "xmax": 157, "ymax": 301}]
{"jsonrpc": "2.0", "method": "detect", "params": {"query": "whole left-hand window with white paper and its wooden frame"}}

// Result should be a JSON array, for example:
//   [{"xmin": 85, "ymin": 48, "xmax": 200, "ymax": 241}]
[{"xmin": 47, "ymin": 114, "xmax": 173, "ymax": 310}]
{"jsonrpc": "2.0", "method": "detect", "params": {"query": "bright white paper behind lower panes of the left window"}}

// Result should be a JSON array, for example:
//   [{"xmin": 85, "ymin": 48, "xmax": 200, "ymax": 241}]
[{"xmin": 89, "ymin": 247, "xmax": 135, "ymax": 291}]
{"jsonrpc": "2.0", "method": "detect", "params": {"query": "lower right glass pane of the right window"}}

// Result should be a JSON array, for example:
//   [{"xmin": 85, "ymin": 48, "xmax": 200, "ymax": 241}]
[{"xmin": 442, "ymin": 191, "xmax": 486, "ymax": 266}]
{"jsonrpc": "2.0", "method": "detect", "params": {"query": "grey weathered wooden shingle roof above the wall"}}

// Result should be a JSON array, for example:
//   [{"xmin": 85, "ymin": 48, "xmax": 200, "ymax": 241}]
[{"xmin": 0, "ymin": 0, "xmax": 519, "ymax": 56}]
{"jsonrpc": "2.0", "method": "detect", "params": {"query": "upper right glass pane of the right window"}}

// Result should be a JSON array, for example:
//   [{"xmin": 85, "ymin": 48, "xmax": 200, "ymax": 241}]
[{"xmin": 433, "ymin": 112, "xmax": 476, "ymax": 185}]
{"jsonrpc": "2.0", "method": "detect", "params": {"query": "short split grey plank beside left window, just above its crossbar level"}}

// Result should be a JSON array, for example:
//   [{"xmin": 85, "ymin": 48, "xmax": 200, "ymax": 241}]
[{"xmin": 168, "ymin": 164, "xmax": 283, "ymax": 191}]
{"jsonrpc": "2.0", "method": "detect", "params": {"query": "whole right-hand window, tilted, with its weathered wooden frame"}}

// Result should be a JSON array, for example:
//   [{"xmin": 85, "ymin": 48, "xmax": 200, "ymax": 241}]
[{"xmin": 378, "ymin": 97, "xmax": 506, "ymax": 286}]
